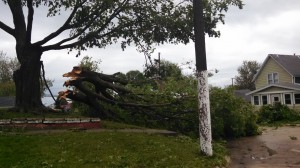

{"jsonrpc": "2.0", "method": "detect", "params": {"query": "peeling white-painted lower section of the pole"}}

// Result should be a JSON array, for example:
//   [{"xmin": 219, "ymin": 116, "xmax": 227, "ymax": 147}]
[{"xmin": 196, "ymin": 71, "xmax": 213, "ymax": 156}]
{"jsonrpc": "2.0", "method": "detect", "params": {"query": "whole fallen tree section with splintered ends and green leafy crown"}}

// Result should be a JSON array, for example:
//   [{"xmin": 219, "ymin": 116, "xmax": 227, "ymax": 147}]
[{"xmin": 62, "ymin": 67, "xmax": 257, "ymax": 139}]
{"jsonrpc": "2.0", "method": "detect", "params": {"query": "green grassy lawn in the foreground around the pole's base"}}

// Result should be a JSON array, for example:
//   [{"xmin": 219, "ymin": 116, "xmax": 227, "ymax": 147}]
[{"xmin": 0, "ymin": 108, "xmax": 226, "ymax": 168}]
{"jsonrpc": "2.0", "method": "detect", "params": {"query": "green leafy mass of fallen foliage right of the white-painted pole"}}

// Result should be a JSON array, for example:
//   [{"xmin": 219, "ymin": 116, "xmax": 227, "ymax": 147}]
[{"xmin": 210, "ymin": 87, "xmax": 258, "ymax": 139}]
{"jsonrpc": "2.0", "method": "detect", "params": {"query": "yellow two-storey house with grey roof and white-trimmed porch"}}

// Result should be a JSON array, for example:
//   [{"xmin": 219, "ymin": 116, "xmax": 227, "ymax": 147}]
[{"xmin": 246, "ymin": 54, "xmax": 300, "ymax": 110}]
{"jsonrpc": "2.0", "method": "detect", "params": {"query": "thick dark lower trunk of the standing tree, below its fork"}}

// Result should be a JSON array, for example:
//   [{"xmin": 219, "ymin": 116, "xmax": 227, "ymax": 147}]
[{"xmin": 14, "ymin": 47, "xmax": 44, "ymax": 112}]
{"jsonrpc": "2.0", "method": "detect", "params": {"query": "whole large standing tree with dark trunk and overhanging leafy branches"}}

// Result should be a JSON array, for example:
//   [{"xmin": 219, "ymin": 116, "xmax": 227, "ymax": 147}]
[{"xmin": 0, "ymin": 0, "xmax": 242, "ymax": 111}]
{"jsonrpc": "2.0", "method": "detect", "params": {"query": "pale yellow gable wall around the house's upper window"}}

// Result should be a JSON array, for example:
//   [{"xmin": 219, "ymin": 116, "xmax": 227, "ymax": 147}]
[{"xmin": 255, "ymin": 56, "xmax": 293, "ymax": 89}]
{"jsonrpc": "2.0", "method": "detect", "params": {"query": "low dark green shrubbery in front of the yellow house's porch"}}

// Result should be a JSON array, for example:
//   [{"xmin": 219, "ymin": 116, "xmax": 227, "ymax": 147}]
[{"xmin": 258, "ymin": 103, "xmax": 300, "ymax": 123}]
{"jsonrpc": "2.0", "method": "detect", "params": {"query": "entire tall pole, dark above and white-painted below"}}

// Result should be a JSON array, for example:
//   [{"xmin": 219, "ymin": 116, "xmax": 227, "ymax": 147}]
[{"xmin": 193, "ymin": 0, "xmax": 213, "ymax": 156}]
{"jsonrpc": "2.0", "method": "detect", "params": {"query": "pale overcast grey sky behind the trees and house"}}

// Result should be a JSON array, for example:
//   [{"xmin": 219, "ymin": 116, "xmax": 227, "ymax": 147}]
[{"xmin": 0, "ymin": 0, "xmax": 300, "ymax": 93}]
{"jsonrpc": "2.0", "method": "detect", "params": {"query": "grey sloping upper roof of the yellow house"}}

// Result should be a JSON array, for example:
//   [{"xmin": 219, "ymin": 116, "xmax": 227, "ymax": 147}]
[{"xmin": 253, "ymin": 54, "xmax": 300, "ymax": 81}]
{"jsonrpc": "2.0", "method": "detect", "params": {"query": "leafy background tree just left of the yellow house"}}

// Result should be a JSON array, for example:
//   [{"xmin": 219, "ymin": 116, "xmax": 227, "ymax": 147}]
[{"xmin": 235, "ymin": 61, "xmax": 261, "ymax": 90}]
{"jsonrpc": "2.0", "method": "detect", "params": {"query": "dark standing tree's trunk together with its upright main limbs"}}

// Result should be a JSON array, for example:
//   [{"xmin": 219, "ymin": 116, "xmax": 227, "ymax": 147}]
[{"xmin": 5, "ymin": 0, "xmax": 44, "ymax": 112}]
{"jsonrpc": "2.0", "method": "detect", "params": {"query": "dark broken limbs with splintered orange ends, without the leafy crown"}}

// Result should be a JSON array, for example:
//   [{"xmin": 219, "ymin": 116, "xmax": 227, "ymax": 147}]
[{"xmin": 59, "ymin": 66, "xmax": 178, "ymax": 119}]
